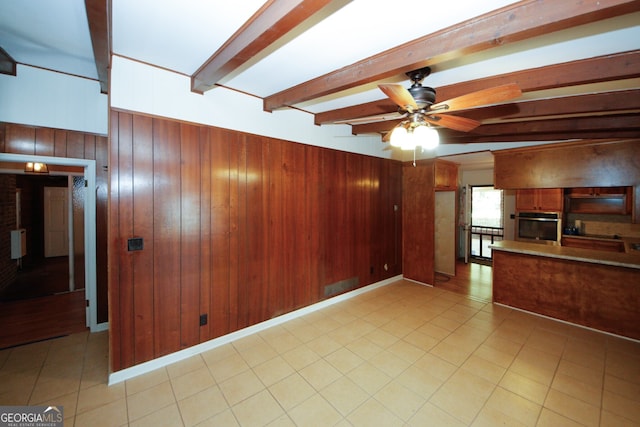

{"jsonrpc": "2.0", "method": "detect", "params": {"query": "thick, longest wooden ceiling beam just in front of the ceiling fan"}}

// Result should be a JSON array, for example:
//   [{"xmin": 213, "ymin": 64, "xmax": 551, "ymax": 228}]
[{"xmin": 264, "ymin": 0, "xmax": 640, "ymax": 111}]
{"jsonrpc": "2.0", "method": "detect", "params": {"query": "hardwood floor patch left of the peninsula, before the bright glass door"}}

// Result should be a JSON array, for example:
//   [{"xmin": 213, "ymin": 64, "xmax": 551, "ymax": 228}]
[{"xmin": 435, "ymin": 260, "xmax": 493, "ymax": 302}]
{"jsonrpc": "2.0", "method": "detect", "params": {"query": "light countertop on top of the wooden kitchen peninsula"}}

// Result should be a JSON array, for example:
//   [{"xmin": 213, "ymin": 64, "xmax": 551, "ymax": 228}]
[{"xmin": 491, "ymin": 239, "xmax": 640, "ymax": 270}]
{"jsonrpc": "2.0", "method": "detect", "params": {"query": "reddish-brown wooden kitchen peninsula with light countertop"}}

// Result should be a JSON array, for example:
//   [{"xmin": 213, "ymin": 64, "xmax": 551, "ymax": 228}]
[{"xmin": 493, "ymin": 241, "xmax": 640, "ymax": 340}]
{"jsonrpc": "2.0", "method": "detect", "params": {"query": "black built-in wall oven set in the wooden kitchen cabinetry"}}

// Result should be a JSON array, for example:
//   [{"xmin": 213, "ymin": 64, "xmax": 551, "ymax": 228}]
[{"xmin": 515, "ymin": 212, "xmax": 562, "ymax": 245}]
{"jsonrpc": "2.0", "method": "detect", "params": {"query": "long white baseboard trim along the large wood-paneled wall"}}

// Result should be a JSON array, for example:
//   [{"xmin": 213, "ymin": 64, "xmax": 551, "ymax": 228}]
[{"xmin": 109, "ymin": 275, "xmax": 403, "ymax": 385}]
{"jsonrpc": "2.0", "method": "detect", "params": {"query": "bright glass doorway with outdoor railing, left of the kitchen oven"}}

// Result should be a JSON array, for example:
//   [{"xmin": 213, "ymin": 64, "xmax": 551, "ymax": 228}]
[{"xmin": 469, "ymin": 185, "xmax": 504, "ymax": 265}]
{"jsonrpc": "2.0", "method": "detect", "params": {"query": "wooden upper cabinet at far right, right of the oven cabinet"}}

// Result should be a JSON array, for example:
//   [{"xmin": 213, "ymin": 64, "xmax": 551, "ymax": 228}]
[{"xmin": 565, "ymin": 187, "xmax": 633, "ymax": 215}]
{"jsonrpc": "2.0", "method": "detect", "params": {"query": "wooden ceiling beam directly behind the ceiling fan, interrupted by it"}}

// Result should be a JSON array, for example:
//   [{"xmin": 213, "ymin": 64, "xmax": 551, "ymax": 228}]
[{"xmin": 315, "ymin": 50, "xmax": 640, "ymax": 124}]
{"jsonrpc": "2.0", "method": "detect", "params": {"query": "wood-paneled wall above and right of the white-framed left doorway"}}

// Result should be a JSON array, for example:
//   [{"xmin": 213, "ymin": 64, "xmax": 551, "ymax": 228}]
[{"xmin": 0, "ymin": 123, "xmax": 109, "ymax": 323}]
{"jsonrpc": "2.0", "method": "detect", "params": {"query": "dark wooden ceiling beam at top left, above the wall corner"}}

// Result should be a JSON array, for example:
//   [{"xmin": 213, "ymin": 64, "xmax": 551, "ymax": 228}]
[{"xmin": 84, "ymin": 0, "xmax": 111, "ymax": 93}]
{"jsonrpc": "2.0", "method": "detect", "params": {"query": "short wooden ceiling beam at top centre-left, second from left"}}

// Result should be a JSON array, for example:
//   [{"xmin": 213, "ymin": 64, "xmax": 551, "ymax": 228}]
[{"xmin": 191, "ymin": 0, "xmax": 331, "ymax": 93}]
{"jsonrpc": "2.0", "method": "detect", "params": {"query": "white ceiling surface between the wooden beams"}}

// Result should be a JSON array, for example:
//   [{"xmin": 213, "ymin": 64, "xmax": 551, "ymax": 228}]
[{"xmin": 0, "ymin": 0, "xmax": 640, "ymax": 155}]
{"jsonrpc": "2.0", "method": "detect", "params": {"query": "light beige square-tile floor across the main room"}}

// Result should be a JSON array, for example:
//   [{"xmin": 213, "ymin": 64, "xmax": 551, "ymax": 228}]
[{"xmin": 0, "ymin": 281, "xmax": 640, "ymax": 427}]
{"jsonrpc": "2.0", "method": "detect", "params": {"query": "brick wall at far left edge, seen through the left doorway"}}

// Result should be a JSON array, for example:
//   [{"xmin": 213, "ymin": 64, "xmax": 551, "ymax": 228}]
[{"xmin": 0, "ymin": 174, "xmax": 17, "ymax": 290}]
